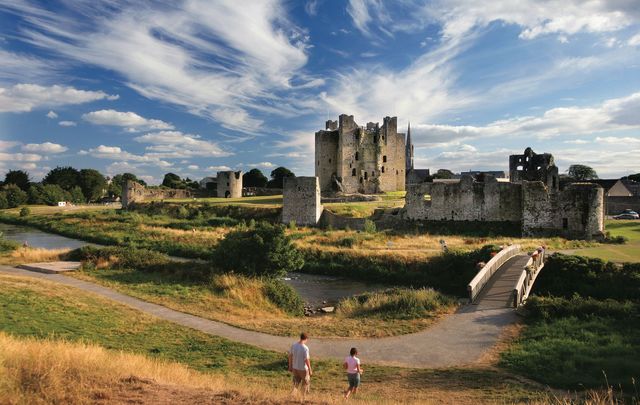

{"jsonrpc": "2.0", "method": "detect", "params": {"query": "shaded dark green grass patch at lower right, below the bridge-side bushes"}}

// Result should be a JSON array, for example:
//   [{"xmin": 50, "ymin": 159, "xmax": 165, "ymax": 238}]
[{"xmin": 500, "ymin": 316, "xmax": 640, "ymax": 391}]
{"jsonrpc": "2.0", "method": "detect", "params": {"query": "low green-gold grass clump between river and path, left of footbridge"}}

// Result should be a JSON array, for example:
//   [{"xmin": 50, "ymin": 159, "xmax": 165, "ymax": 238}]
[{"xmin": 337, "ymin": 288, "xmax": 455, "ymax": 319}]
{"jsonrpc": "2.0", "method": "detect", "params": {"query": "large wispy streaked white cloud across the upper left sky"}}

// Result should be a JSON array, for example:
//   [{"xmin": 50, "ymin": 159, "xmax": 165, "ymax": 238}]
[{"xmin": 12, "ymin": 0, "xmax": 315, "ymax": 132}]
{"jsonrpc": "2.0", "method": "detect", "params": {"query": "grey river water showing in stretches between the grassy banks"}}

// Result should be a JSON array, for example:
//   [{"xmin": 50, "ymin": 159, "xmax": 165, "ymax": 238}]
[{"xmin": 0, "ymin": 223, "xmax": 383, "ymax": 308}]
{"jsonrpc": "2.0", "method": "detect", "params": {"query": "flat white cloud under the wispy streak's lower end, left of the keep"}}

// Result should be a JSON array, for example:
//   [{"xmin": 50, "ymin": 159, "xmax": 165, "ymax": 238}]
[{"xmin": 134, "ymin": 131, "xmax": 231, "ymax": 158}]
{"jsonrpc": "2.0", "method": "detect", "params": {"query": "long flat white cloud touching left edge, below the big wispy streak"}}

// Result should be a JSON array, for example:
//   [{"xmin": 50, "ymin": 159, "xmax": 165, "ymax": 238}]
[{"xmin": 0, "ymin": 83, "xmax": 119, "ymax": 112}]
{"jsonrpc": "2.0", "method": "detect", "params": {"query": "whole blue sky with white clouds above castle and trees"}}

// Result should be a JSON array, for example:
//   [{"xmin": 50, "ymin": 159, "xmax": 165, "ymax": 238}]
[{"xmin": 0, "ymin": 0, "xmax": 640, "ymax": 183}]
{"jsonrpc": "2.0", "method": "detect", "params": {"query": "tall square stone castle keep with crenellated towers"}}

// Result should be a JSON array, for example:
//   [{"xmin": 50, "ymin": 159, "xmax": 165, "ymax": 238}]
[{"xmin": 315, "ymin": 114, "xmax": 406, "ymax": 194}]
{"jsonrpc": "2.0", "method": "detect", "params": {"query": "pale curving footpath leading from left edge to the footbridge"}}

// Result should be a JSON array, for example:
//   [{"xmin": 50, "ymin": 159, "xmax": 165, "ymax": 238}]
[{"xmin": 0, "ymin": 261, "xmax": 519, "ymax": 368}]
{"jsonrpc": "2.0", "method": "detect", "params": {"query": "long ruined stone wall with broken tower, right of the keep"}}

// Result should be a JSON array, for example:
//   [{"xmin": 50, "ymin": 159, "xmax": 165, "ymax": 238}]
[{"xmin": 403, "ymin": 148, "xmax": 604, "ymax": 239}]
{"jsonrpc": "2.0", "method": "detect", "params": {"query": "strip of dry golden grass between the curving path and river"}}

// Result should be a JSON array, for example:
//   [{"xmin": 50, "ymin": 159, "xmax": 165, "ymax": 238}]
[{"xmin": 71, "ymin": 269, "xmax": 456, "ymax": 337}]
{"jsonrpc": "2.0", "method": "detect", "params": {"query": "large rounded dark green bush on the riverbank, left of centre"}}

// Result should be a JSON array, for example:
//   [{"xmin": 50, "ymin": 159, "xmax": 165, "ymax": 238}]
[{"xmin": 214, "ymin": 222, "xmax": 304, "ymax": 277}]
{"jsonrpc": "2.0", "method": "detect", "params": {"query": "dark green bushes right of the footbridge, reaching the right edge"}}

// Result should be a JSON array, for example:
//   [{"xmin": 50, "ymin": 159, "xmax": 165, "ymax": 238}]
[{"xmin": 533, "ymin": 253, "xmax": 640, "ymax": 300}]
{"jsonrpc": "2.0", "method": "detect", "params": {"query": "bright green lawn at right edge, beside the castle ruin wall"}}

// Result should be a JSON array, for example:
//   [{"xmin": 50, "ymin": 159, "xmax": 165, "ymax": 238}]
[{"xmin": 571, "ymin": 220, "xmax": 640, "ymax": 262}]
